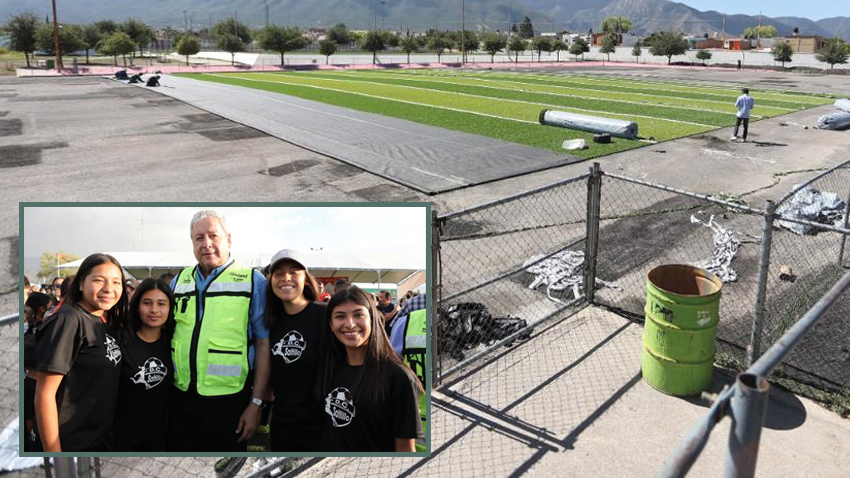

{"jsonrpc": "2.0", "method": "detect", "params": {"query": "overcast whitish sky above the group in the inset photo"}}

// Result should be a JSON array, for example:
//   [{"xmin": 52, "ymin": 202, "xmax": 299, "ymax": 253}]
[{"xmin": 21, "ymin": 206, "xmax": 428, "ymax": 269}]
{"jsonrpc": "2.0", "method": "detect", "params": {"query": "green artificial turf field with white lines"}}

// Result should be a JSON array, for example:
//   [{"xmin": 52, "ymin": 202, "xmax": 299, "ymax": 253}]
[{"xmin": 179, "ymin": 70, "xmax": 834, "ymax": 158}]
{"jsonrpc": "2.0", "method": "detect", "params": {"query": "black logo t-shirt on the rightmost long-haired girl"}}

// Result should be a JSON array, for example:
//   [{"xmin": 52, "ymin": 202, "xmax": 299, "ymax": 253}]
[{"xmin": 322, "ymin": 362, "xmax": 424, "ymax": 452}]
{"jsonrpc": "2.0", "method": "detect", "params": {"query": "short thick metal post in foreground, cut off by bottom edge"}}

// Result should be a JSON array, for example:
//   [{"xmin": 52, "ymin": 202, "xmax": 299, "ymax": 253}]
[{"xmin": 723, "ymin": 373, "xmax": 770, "ymax": 477}]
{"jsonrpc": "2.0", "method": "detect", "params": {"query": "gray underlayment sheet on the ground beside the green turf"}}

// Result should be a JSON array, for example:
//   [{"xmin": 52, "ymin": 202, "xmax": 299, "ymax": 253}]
[{"xmin": 154, "ymin": 75, "xmax": 581, "ymax": 194}]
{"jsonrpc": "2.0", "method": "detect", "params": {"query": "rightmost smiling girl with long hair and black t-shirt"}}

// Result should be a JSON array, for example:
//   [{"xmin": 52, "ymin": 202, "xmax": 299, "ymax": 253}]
[{"xmin": 316, "ymin": 286, "xmax": 423, "ymax": 452}]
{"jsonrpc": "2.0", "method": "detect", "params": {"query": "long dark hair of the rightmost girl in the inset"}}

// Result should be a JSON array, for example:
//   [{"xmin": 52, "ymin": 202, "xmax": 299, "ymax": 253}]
[{"xmin": 315, "ymin": 285, "xmax": 422, "ymax": 401}]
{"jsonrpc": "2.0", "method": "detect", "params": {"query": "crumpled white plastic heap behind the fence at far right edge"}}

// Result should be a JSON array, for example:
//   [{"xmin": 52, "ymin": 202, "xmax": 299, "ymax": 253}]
[{"xmin": 776, "ymin": 186, "xmax": 847, "ymax": 236}]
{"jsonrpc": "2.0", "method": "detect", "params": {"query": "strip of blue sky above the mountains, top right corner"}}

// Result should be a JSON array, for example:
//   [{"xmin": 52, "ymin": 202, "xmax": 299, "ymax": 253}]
[{"xmin": 674, "ymin": 0, "xmax": 850, "ymax": 20}]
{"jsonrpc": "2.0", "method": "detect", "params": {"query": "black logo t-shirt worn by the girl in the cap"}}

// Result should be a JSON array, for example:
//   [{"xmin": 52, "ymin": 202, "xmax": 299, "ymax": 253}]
[{"xmin": 269, "ymin": 302, "xmax": 327, "ymax": 446}]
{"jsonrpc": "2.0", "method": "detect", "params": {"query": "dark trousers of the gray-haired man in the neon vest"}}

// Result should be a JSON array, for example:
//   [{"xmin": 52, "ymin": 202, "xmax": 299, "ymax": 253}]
[{"xmin": 166, "ymin": 386, "xmax": 251, "ymax": 452}]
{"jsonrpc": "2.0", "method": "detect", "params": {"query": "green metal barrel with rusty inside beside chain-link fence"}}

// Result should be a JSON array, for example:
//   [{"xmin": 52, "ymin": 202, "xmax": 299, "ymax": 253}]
[{"xmin": 641, "ymin": 264, "xmax": 723, "ymax": 395}]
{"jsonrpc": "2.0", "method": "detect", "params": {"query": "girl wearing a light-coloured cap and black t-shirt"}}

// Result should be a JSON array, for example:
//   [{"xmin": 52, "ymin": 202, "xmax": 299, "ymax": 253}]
[{"xmin": 265, "ymin": 249, "xmax": 326, "ymax": 452}]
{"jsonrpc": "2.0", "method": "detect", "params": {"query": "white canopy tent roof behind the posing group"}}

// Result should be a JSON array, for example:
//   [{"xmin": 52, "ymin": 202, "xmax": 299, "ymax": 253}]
[{"xmin": 58, "ymin": 251, "xmax": 425, "ymax": 284}]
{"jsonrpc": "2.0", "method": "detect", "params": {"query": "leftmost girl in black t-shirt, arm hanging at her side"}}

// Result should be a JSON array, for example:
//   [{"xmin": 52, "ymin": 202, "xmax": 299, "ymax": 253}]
[{"xmin": 35, "ymin": 254, "xmax": 127, "ymax": 452}]
